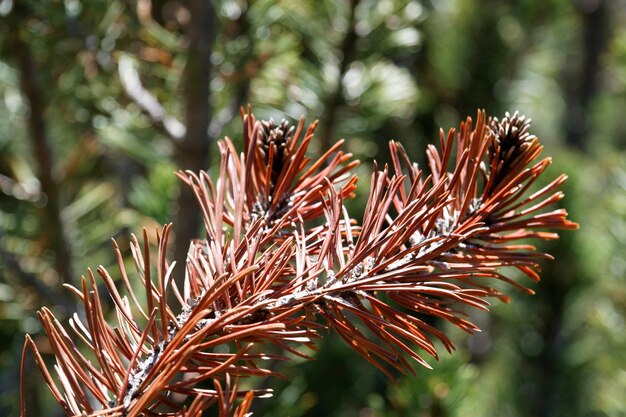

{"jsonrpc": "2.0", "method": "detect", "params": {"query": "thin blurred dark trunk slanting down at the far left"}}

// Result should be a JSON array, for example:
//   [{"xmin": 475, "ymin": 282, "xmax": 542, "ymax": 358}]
[{"xmin": 11, "ymin": 18, "xmax": 75, "ymax": 285}]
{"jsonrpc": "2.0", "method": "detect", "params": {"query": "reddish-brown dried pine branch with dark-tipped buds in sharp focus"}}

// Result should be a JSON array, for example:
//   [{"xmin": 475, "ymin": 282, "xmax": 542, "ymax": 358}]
[{"xmin": 22, "ymin": 111, "xmax": 577, "ymax": 417}]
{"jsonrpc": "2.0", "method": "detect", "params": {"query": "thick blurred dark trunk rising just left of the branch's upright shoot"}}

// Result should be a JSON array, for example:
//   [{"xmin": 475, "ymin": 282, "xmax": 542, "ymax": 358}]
[{"xmin": 174, "ymin": 0, "xmax": 217, "ymax": 300}]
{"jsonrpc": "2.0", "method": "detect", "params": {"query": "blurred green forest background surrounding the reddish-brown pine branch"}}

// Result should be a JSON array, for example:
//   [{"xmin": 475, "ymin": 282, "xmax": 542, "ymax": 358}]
[{"xmin": 0, "ymin": 0, "xmax": 626, "ymax": 417}]
